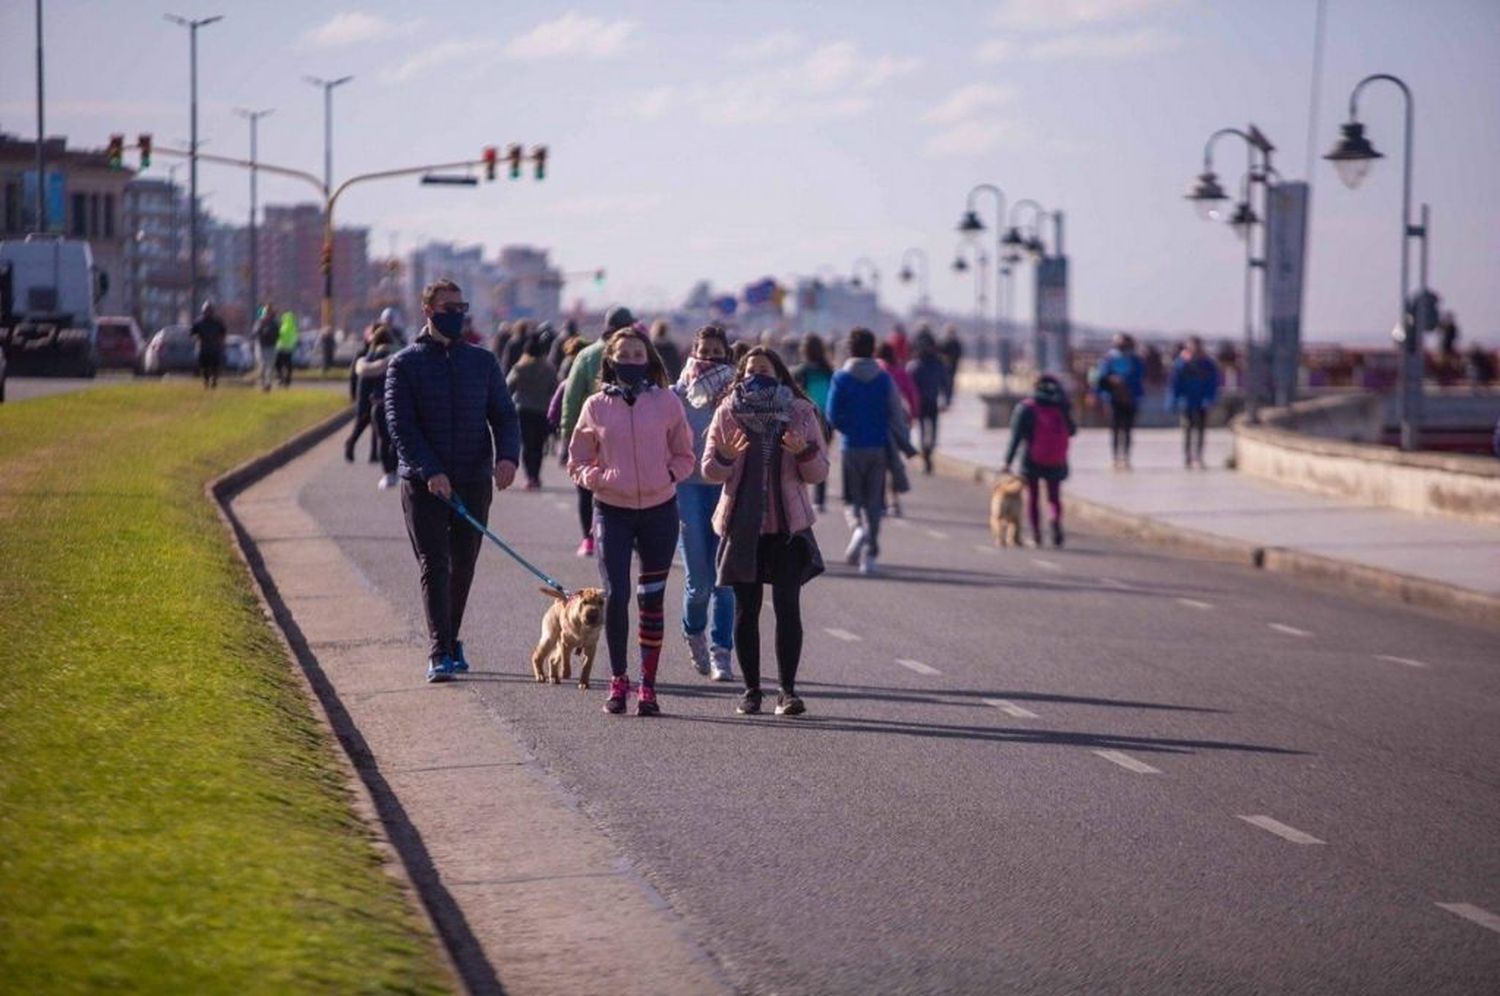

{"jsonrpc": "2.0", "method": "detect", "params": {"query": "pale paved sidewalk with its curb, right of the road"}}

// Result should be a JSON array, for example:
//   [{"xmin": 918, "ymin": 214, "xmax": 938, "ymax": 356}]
[{"xmin": 938, "ymin": 395, "xmax": 1500, "ymax": 621}]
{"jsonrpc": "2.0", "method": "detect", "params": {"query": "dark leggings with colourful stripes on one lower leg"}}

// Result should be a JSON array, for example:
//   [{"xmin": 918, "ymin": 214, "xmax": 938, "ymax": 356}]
[{"xmin": 594, "ymin": 497, "xmax": 678, "ymax": 684}]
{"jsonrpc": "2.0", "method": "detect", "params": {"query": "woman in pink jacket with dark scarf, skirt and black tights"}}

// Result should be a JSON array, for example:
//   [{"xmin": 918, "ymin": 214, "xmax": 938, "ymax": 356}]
[{"xmin": 701, "ymin": 347, "xmax": 828, "ymax": 716}]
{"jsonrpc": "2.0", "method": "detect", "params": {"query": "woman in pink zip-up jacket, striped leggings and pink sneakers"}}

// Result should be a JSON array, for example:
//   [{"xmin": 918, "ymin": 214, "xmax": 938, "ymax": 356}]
[{"xmin": 567, "ymin": 327, "xmax": 693, "ymax": 716}]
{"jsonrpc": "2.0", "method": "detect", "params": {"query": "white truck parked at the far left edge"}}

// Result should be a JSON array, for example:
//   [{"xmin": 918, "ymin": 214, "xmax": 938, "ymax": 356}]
[{"xmin": 0, "ymin": 236, "xmax": 110, "ymax": 377}]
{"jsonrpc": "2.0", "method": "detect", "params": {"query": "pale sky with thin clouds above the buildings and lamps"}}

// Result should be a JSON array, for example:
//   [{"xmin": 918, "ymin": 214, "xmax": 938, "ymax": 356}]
[{"xmin": 0, "ymin": 0, "xmax": 1500, "ymax": 345}]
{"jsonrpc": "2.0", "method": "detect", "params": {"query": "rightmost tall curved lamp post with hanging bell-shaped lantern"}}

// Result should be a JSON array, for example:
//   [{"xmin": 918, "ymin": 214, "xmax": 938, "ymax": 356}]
[{"xmin": 1323, "ymin": 72, "xmax": 1427, "ymax": 452}]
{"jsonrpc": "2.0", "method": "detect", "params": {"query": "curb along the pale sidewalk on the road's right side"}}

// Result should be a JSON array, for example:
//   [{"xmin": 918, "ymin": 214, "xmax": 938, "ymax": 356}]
[{"xmin": 933, "ymin": 453, "xmax": 1500, "ymax": 627}]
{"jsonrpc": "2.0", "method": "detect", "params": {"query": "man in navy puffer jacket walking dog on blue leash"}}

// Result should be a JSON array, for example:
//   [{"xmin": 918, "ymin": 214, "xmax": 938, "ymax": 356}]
[{"xmin": 386, "ymin": 279, "xmax": 521, "ymax": 681}]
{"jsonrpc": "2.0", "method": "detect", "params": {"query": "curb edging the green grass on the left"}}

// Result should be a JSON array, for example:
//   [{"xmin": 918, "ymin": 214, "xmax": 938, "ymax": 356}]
[{"xmin": 204, "ymin": 405, "xmax": 474, "ymax": 992}]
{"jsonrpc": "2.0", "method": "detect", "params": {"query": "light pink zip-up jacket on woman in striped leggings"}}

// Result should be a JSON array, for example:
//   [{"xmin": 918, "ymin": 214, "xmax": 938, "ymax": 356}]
[{"xmin": 567, "ymin": 386, "xmax": 693, "ymax": 509}]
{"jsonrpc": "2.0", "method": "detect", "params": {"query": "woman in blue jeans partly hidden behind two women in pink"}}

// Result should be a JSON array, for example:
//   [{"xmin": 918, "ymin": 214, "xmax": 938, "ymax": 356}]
[{"xmin": 672, "ymin": 326, "xmax": 735, "ymax": 681}]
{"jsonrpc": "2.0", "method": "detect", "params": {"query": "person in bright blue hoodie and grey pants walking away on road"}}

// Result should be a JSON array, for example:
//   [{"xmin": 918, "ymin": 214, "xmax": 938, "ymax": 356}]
[{"xmin": 828, "ymin": 329, "xmax": 906, "ymax": 575}]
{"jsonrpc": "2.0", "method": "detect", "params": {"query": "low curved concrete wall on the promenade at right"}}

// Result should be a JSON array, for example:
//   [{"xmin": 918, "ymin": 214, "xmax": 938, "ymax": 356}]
[{"xmin": 1233, "ymin": 395, "xmax": 1500, "ymax": 524}]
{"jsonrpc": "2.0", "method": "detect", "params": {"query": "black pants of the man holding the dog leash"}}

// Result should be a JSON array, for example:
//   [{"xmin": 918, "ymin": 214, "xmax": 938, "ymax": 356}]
[{"xmin": 401, "ymin": 480, "xmax": 494, "ymax": 656}]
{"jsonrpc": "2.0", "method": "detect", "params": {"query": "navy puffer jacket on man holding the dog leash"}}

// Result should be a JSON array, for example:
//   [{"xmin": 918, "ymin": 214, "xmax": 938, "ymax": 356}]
[{"xmin": 386, "ymin": 330, "xmax": 521, "ymax": 485}]
